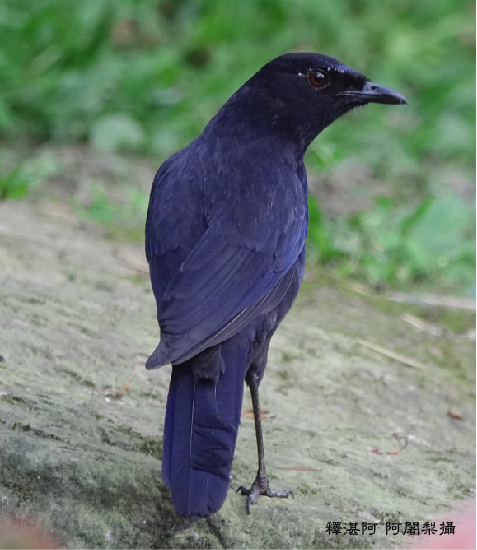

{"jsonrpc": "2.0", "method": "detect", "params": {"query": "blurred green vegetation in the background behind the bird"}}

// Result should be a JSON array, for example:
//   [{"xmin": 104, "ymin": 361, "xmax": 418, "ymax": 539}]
[{"xmin": 0, "ymin": 0, "xmax": 475, "ymax": 292}]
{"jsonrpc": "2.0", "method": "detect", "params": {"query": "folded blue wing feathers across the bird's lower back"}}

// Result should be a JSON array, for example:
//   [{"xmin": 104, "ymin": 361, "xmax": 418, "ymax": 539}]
[{"xmin": 147, "ymin": 211, "xmax": 307, "ymax": 368}]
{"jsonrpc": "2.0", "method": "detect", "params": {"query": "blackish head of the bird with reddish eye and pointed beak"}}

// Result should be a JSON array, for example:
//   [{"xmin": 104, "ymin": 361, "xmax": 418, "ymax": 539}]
[{"xmin": 218, "ymin": 53, "xmax": 407, "ymax": 150}]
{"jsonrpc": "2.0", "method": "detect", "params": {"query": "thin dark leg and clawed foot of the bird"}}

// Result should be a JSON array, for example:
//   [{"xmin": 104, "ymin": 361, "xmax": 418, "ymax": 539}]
[{"xmin": 237, "ymin": 369, "xmax": 293, "ymax": 514}]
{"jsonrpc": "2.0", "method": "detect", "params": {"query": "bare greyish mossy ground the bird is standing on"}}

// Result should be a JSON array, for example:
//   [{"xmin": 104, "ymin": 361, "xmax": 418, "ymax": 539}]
[{"xmin": 0, "ymin": 196, "xmax": 475, "ymax": 548}]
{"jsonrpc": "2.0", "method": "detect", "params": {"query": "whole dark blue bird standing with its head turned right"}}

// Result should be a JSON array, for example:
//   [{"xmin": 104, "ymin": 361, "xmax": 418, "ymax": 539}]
[{"xmin": 146, "ymin": 53, "xmax": 406, "ymax": 518}]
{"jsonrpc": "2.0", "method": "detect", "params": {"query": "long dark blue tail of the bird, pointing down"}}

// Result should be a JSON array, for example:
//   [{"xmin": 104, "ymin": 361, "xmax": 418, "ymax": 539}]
[{"xmin": 162, "ymin": 337, "xmax": 248, "ymax": 518}]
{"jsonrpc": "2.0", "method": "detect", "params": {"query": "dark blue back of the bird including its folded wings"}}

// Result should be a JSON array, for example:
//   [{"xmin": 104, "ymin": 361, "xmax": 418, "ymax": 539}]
[{"xmin": 146, "ymin": 129, "xmax": 307, "ymax": 367}]
